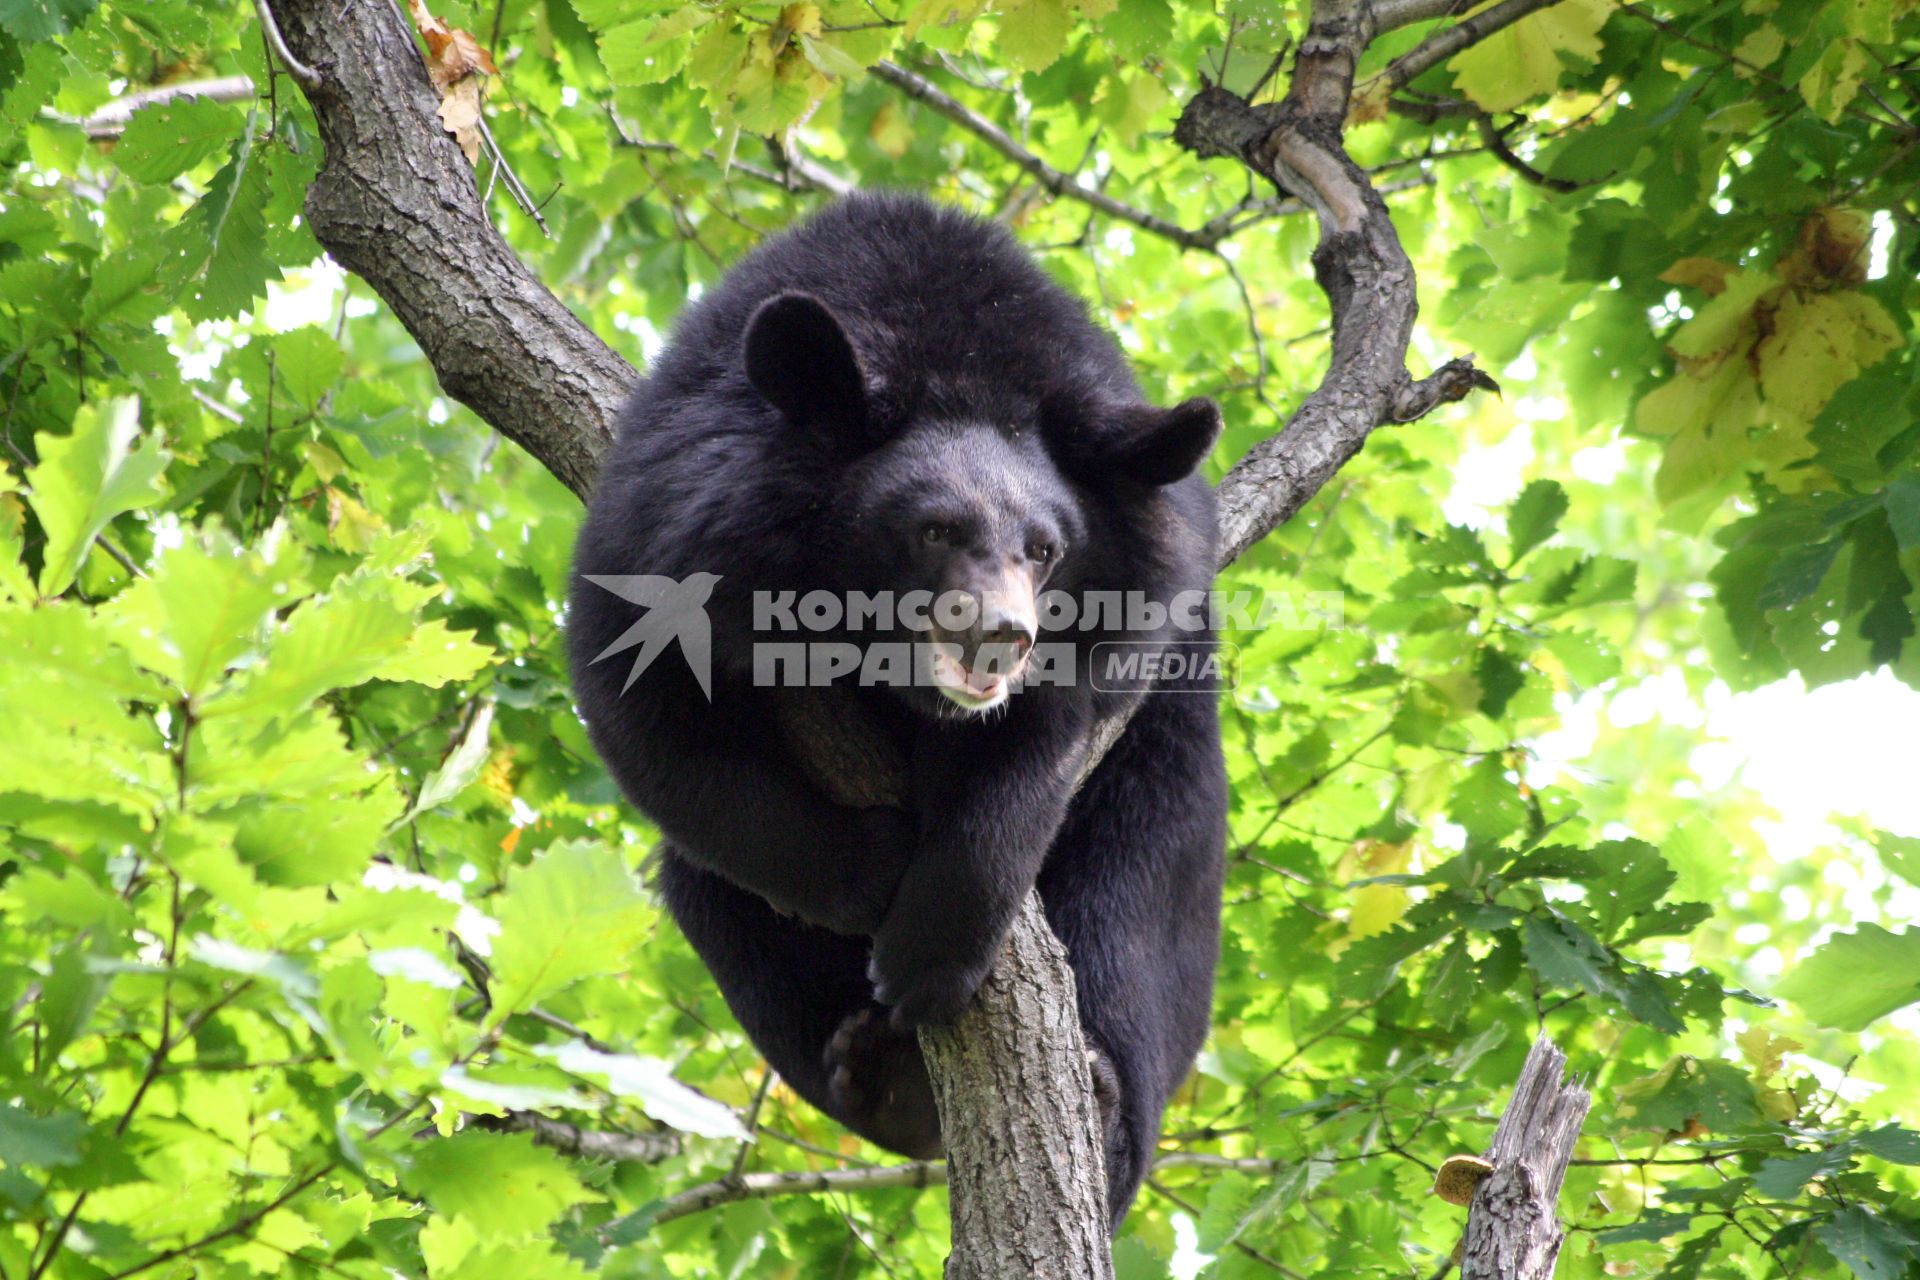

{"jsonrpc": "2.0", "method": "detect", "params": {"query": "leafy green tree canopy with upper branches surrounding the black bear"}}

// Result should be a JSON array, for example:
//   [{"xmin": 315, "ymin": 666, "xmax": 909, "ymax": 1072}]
[{"xmin": 0, "ymin": 0, "xmax": 1920, "ymax": 1276}]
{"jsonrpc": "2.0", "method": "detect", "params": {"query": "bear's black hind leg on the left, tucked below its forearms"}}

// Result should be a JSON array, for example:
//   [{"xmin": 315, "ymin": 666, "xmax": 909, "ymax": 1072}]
[{"xmin": 655, "ymin": 844, "xmax": 941, "ymax": 1159}]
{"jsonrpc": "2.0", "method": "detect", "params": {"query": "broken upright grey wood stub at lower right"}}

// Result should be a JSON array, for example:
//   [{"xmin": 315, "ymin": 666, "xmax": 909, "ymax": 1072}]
[{"xmin": 1459, "ymin": 1036, "xmax": 1592, "ymax": 1280}]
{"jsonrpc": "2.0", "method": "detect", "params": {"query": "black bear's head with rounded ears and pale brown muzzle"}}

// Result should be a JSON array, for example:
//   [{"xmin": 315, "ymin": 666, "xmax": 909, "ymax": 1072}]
[{"xmin": 743, "ymin": 292, "xmax": 1219, "ymax": 714}]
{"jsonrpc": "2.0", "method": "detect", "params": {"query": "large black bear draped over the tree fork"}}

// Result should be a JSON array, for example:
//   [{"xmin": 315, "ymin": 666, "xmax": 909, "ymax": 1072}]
[{"xmin": 570, "ymin": 194, "xmax": 1227, "ymax": 1228}]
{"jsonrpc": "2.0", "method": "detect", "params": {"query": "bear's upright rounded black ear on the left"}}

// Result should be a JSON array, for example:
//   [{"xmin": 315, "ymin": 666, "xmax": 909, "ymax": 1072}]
[{"xmin": 743, "ymin": 294, "xmax": 866, "ymax": 439}]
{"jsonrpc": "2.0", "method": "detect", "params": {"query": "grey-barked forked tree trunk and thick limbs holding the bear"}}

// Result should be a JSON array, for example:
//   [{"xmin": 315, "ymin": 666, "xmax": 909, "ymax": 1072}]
[{"xmin": 271, "ymin": 0, "xmax": 1492, "ymax": 1280}]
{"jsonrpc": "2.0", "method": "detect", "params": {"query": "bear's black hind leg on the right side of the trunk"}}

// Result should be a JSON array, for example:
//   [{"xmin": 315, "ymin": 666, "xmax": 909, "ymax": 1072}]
[{"xmin": 1039, "ymin": 693, "xmax": 1227, "ymax": 1230}]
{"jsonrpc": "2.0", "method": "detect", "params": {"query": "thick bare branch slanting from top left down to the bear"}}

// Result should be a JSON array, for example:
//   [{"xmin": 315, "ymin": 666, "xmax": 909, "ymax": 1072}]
[{"xmin": 273, "ymin": 0, "xmax": 634, "ymax": 497}]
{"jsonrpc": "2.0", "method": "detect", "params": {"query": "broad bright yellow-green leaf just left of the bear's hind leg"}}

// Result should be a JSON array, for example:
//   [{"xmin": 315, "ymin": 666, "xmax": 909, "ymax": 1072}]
[{"xmin": 492, "ymin": 841, "xmax": 655, "ymax": 1021}]
